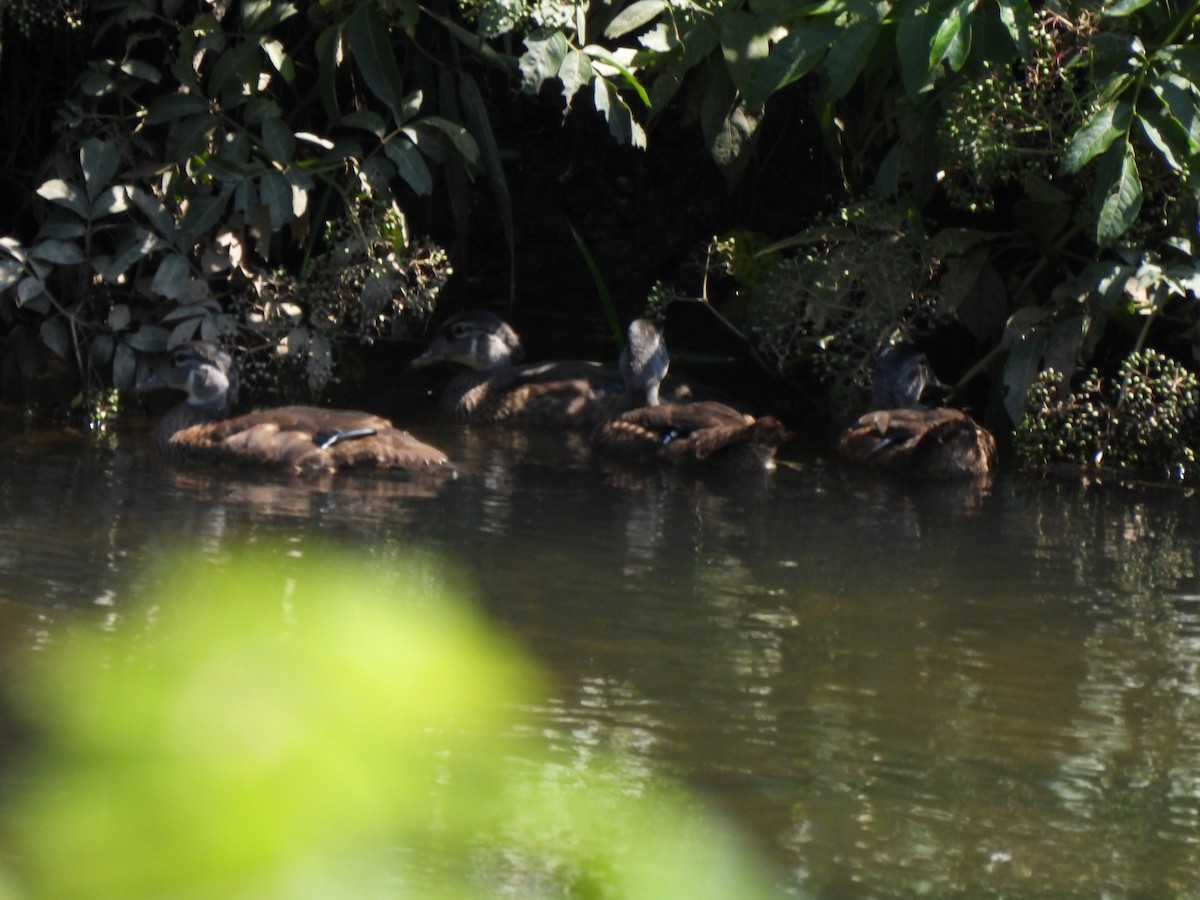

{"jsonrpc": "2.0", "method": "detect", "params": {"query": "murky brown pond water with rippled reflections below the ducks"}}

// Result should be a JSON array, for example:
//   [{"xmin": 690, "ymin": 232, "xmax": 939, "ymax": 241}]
[{"xmin": 0, "ymin": 410, "xmax": 1200, "ymax": 898}]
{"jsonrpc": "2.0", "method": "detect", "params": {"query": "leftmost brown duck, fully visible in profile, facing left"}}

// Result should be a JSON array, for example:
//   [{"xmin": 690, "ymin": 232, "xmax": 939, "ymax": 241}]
[{"xmin": 138, "ymin": 341, "xmax": 449, "ymax": 473}]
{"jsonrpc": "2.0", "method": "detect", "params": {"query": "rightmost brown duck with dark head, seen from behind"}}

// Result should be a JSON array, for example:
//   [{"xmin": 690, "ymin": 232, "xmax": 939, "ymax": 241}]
[{"xmin": 836, "ymin": 343, "xmax": 996, "ymax": 479}]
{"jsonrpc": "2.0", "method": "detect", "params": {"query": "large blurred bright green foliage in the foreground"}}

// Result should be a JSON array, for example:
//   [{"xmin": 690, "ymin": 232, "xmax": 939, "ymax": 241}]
[{"xmin": 0, "ymin": 550, "xmax": 770, "ymax": 899}]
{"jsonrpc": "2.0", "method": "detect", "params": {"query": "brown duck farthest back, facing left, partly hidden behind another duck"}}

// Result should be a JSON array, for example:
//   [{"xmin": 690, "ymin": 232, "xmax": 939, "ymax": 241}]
[{"xmin": 409, "ymin": 311, "xmax": 729, "ymax": 431}]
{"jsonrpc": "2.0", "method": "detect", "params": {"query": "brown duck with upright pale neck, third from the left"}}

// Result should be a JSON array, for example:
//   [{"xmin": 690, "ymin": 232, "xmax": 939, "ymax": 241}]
[{"xmin": 593, "ymin": 319, "xmax": 790, "ymax": 470}]
